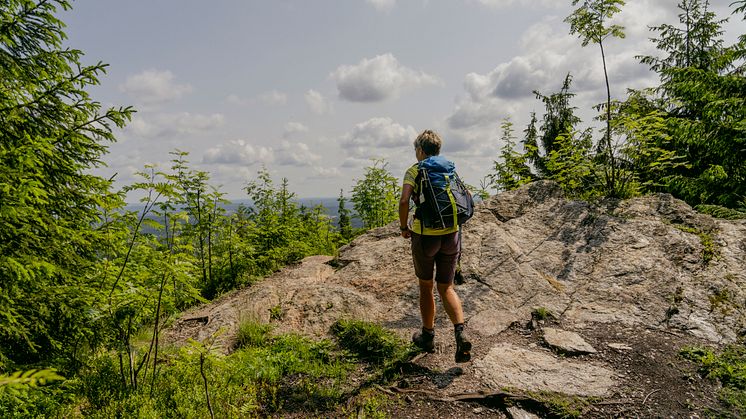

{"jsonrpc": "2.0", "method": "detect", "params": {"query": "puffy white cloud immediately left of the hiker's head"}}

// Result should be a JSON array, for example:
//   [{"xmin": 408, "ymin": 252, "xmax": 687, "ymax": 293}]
[{"xmin": 341, "ymin": 118, "xmax": 417, "ymax": 157}]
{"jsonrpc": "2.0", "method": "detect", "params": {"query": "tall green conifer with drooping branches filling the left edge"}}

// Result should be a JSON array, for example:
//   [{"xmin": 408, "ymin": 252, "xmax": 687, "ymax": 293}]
[{"xmin": 0, "ymin": 0, "xmax": 132, "ymax": 363}]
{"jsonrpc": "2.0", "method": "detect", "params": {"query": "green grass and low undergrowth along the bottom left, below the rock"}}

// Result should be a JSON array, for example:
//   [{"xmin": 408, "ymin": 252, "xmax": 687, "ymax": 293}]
[{"xmin": 0, "ymin": 321, "xmax": 411, "ymax": 418}]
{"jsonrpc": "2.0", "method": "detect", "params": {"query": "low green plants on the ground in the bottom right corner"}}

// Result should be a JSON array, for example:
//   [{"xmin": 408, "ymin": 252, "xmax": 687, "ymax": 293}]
[{"xmin": 680, "ymin": 344, "xmax": 746, "ymax": 417}]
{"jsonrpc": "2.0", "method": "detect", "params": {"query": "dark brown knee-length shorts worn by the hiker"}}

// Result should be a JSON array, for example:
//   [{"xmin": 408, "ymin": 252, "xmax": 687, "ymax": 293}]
[{"xmin": 412, "ymin": 231, "xmax": 460, "ymax": 284}]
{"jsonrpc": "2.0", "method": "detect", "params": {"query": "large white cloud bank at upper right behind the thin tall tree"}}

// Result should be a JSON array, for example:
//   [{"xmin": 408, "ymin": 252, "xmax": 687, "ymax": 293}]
[{"xmin": 447, "ymin": 0, "xmax": 676, "ymax": 132}]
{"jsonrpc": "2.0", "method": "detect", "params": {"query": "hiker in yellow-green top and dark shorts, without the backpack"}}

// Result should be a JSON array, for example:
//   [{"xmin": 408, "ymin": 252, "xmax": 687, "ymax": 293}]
[{"xmin": 399, "ymin": 130, "xmax": 471, "ymax": 362}]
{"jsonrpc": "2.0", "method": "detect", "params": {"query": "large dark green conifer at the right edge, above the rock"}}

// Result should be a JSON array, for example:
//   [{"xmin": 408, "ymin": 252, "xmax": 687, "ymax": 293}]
[{"xmin": 633, "ymin": 0, "xmax": 746, "ymax": 208}]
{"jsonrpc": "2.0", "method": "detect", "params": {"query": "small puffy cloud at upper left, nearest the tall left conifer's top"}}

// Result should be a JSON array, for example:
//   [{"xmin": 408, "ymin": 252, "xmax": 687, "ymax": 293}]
[{"xmin": 119, "ymin": 69, "xmax": 192, "ymax": 105}]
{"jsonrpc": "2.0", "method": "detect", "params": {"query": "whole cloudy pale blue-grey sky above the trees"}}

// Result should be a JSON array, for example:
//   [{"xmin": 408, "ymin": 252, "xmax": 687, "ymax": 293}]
[{"xmin": 62, "ymin": 0, "xmax": 743, "ymax": 198}]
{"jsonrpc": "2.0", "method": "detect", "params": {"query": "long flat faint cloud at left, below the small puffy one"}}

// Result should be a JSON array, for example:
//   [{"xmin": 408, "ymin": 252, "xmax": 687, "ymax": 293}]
[{"xmin": 125, "ymin": 112, "xmax": 225, "ymax": 139}]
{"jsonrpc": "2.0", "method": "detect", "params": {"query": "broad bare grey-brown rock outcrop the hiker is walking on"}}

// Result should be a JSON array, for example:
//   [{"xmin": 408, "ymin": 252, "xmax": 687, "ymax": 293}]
[{"xmin": 168, "ymin": 182, "xmax": 746, "ymax": 408}]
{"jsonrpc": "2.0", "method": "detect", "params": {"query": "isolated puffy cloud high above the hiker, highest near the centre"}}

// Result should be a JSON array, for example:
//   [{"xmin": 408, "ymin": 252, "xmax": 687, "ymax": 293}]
[{"xmin": 331, "ymin": 54, "xmax": 442, "ymax": 102}]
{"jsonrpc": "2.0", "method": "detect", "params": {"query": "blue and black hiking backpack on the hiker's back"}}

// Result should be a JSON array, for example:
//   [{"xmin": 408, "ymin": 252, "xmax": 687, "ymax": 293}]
[{"xmin": 414, "ymin": 156, "xmax": 474, "ymax": 229}]
